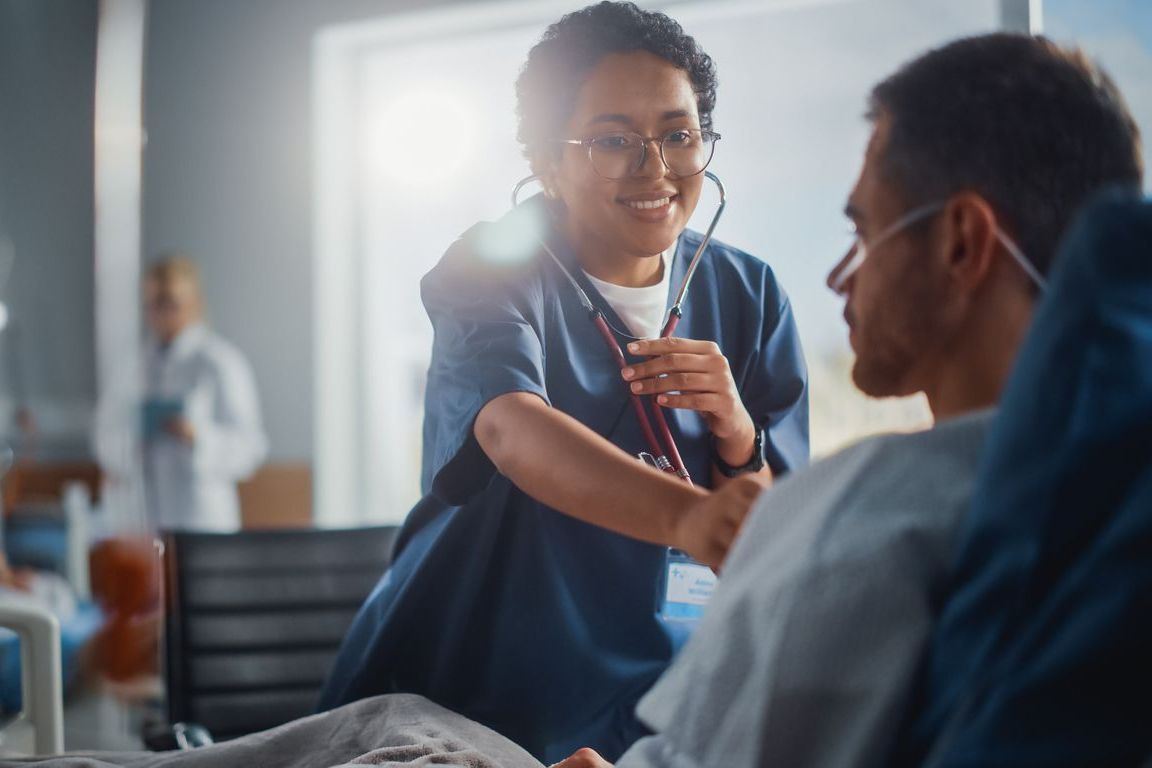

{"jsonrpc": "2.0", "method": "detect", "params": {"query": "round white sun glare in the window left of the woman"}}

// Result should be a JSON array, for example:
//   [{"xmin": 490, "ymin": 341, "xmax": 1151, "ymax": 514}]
[{"xmin": 364, "ymin": 83, "xmax": 480, "ymax": 189}]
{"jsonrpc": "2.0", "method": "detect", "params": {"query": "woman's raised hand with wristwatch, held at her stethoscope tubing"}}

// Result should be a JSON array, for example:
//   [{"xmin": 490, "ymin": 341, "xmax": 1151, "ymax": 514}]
[{"xmin": 622, "ymin": 336, "xmax": 756, "ymax": 466}]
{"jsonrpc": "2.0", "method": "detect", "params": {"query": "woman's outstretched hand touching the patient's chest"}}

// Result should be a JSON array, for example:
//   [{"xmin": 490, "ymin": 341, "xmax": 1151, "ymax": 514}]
[{"xmin": 673, "ymin": 474, "xmax": 768, "ymax": 572}]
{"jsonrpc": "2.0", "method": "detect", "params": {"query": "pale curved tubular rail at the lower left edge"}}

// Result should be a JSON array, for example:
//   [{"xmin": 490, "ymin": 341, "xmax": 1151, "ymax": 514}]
[{"xmin": 0, "ymin": 602, "xmax": 65, "ymax": 755}]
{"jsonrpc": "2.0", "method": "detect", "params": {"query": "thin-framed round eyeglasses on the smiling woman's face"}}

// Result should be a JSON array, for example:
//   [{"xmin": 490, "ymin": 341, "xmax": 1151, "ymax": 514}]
[{"xmin": 560, "ymin": 128, "xmax": 720, "ymax": 181}]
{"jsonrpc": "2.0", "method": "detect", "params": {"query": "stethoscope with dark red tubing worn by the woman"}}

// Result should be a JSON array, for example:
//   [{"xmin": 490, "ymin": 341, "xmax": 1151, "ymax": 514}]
[{"xmin": 511, "ymin": 170, "xmax": 727, "ymax": 484}]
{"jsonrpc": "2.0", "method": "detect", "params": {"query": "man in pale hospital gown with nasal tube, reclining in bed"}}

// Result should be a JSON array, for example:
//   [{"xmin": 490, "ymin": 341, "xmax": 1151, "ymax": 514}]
[{"xmin": 559, "ymin": 35, "xmax": 1142, "ymax": 768}]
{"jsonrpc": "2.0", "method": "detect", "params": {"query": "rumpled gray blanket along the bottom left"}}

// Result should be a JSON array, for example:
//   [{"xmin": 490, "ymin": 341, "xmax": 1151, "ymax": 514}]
[{"xmin": 0, "ymin": 694, "xmax": 541, "ymax": 768}]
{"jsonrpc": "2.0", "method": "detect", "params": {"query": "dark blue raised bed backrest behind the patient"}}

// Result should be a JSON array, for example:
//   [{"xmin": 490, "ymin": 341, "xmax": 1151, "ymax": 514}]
[{"xmin": 4, "ymin": 191, "xmax": 1152, "ymax": 768}]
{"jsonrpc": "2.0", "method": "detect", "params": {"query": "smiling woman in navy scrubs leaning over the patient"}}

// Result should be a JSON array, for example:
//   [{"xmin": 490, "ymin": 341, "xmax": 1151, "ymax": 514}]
[{"xmin": 321, "ymin": 2, "xmax": 808, "ymax": 763}]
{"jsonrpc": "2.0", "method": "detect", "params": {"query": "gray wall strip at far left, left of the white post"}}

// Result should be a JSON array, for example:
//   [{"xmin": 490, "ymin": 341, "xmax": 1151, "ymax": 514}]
[{"xmin": 0, "ymin": 0, "xmax": 97, "ymax": 455}]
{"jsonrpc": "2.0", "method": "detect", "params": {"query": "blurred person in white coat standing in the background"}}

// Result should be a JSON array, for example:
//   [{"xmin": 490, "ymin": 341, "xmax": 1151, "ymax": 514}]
[{"xmin": 93, "ymin": 256, "xmax": 267, "ymax": 531}]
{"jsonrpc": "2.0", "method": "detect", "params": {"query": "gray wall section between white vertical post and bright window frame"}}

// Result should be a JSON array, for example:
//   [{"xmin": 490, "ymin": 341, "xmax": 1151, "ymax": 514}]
[{"xmin": 143, "ymin": 0, "xmax": 493, "ymax": 461}]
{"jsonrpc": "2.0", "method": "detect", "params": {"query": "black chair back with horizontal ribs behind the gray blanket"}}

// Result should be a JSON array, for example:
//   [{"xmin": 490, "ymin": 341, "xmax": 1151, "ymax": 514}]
[{"xmin": 164, "ymin": 527, "xmax": 397, "ymax": 739}]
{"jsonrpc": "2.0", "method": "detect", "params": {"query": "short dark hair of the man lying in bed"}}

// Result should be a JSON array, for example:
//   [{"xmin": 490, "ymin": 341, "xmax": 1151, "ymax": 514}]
[{"xmin": 869, "ymin": 33, "xmax": 1143, "ymax": 279}]
